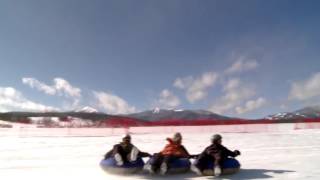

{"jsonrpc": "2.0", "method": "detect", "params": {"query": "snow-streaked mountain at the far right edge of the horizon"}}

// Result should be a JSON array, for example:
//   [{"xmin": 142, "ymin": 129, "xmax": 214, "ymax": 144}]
[{"xmin": 266, "ymin": 106, "xmax": 320, "ymax": 120}]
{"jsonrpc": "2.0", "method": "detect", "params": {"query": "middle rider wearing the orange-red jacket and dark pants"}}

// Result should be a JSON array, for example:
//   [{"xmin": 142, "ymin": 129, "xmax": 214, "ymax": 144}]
[{"xmin": 146, "ymin": 132, "xmax": 194, "ymax": 175}]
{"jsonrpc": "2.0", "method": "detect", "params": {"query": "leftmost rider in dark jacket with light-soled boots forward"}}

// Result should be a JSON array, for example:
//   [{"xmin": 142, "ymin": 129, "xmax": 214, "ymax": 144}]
[{"xmin": 104, "ymin": 134, "xmax": 151, "ymax": 166}]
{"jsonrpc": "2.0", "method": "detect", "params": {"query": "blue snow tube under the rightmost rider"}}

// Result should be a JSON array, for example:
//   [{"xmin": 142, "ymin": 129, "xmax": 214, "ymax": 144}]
[{"xmin": 203, "ymin": 158, "xmax": 241, "ymax": 176}]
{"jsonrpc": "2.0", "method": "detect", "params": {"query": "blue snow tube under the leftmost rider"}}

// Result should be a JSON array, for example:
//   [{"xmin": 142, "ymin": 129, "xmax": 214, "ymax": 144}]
[{"xmin": 100, "ymin": 158, "xmax": 144, "ymax": 174}]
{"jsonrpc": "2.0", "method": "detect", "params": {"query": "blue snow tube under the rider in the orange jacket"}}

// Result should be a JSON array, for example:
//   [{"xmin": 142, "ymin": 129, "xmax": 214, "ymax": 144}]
[{"xmin": 147, "ymin": 158, "xmax": 191, "ymax": 174}]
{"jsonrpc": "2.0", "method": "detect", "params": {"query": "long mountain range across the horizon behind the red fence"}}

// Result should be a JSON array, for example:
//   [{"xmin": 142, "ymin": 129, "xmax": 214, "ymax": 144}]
[{"xmin": 0, "ymin": 106, "xmax": 320, "ymax": 127}]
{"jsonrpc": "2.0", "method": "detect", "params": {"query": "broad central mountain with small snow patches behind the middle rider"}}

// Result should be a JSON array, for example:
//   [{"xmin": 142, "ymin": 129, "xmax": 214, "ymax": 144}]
[{"xmin": 123, "ymin": 108, "xmax": 231, "ymax": 121}]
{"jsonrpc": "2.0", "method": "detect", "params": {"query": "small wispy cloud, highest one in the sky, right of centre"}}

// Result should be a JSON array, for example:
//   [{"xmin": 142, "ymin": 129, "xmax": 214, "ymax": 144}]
[{"xmin": 225, "ymin": 56, "xmax": 259, "ymax": 74}]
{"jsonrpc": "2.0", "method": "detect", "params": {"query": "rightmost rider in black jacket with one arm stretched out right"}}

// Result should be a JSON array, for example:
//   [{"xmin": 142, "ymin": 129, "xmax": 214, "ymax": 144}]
[{"xmin": 191, "ymin": 134, "xmax": 240, "ymax": 176}]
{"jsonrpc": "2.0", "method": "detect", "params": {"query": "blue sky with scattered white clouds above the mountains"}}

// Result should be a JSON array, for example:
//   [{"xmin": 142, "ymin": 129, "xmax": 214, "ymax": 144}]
[{"xmin": 0, "ymin": 0, "xmax": 320, "ymax": 118}]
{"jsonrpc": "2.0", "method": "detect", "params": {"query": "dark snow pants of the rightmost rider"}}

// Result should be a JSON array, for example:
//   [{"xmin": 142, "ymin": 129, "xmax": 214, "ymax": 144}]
[{"xmin": 195, "ymin": 153, "xmax": 221, "ymax": 171}]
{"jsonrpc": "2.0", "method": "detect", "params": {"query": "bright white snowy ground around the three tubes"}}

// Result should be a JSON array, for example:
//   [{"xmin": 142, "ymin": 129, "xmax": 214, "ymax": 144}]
[{"xmin": 0, "ymin": 126, "xmax": 320, "ymax": 180}]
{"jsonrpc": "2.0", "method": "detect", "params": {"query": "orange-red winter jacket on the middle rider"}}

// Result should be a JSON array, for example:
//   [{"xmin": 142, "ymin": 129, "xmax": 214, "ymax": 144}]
[{"xmin": 160, "ymin": 138, "xmax": 190, "ymax": 158}]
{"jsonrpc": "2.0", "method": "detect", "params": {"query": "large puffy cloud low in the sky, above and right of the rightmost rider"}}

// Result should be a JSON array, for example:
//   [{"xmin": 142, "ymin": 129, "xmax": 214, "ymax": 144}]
[{"xmin": 209, "ymin": 78, "xmax": 256, "ymax": 113}]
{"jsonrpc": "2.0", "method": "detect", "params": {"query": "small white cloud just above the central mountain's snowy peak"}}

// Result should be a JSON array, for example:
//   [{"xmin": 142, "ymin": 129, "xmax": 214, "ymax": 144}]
[{"xmin": 157, "ymin": 89, "xmax": 180, "ymax": 108}]
